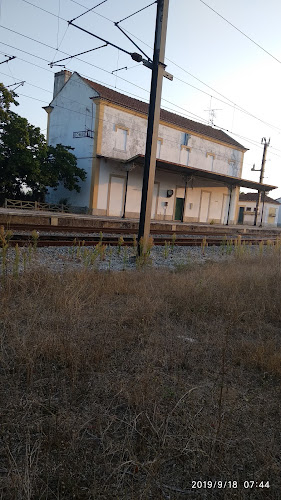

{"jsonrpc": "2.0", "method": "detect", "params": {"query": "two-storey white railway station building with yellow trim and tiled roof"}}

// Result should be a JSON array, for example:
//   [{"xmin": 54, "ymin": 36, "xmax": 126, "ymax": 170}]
[{"xmin": 44, "ymin": 70, "xmax": 275, "ymax": 224}]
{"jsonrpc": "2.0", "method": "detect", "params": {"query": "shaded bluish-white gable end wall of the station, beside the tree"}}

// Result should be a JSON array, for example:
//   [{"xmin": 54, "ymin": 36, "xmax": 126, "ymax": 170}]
[{"xmin": 46, "ymin": 73, "xmax": 96, "ymax": 207}]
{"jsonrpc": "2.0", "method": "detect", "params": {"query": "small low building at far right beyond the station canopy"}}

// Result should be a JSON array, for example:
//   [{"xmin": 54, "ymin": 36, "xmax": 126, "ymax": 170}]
[{"xmin": 238, "ymin": 193, "xmax": 280, "ymax": 226}]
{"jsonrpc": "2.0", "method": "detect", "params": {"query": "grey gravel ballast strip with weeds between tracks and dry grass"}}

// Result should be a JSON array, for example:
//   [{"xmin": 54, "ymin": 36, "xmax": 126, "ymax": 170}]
[{"xmin": 1, "ymin": 245, "xmax": 262, "ymax": 273}]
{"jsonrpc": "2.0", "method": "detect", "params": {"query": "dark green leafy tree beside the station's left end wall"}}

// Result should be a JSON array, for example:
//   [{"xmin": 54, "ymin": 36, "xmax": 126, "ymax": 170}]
[{"xmin": 0, "ymin": 84, "xmax": 86, "ymax": 203}]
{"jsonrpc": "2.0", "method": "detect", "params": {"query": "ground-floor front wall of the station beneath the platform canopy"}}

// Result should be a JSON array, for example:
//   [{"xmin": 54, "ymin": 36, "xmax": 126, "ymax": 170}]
[{"xmin": 96, "ymin": 159, "xmax": 237, "ymax": 223}]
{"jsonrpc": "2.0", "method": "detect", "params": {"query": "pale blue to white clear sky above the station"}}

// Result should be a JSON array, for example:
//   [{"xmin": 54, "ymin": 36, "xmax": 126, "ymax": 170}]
[{"xmin": 0, "ymin": 0, "xmax": 281, "ymax": 199}]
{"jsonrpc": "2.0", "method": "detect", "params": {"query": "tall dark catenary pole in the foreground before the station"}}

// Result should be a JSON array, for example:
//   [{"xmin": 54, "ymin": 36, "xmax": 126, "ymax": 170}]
[{"xmin": 138, "ymin": 0, "xmax": 169, "ymax": 255}]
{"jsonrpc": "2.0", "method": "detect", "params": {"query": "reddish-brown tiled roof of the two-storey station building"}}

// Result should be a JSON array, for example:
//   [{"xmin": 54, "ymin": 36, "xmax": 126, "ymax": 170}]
[{"xmin": 81, "ymin": 77, "xmax": 247, "ymax": 151}]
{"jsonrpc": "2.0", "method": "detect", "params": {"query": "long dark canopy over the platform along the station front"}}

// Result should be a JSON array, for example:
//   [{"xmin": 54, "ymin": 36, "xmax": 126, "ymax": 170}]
[{"xmin": 97, "ymin": 155, "xmax": 277, "ymax": 192}]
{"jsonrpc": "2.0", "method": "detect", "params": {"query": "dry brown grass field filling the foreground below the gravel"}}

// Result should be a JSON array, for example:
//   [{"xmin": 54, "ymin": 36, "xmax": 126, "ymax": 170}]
[{"xmin": 0, "ymin": 255, "xmax": 281, "ymax": 500}]
